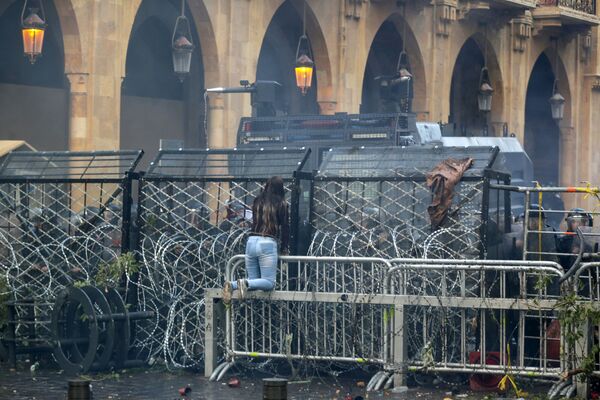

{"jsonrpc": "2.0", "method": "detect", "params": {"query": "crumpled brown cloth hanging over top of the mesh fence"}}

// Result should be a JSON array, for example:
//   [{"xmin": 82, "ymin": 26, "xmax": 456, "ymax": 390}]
[{"xmin": 427, "ymin": 158, "xmax": 473, "ymax": 230}]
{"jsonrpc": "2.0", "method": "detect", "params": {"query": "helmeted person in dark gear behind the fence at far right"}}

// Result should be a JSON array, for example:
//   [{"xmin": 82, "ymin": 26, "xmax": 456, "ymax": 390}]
[{"xmin": 557, "ymin": 208, "xmax": 594, "ymax": 270}]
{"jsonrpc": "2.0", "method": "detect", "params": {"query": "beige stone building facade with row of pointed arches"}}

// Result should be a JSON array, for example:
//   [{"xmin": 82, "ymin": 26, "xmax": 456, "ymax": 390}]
[{"xmin": 1, "ymin": 0, "xmax": 600, "ymax": 205}]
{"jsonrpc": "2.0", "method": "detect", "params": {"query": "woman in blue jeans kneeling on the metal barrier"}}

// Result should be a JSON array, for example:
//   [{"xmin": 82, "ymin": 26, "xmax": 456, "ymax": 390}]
[{"xmin": 223, "ymin": 176, "xmax": 290, "ymax": 303}]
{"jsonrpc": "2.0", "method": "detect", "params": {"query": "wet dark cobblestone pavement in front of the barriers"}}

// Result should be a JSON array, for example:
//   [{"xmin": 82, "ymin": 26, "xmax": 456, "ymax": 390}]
[{"xmin": 0, "ymin": 366, "xmax": 548, "ymax": 400}]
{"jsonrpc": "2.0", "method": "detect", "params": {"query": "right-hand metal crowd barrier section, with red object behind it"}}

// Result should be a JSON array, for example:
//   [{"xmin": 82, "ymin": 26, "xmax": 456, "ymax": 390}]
[{"xmin": 385, "ymin": 259, "xmax": 564, "ymax": 388}]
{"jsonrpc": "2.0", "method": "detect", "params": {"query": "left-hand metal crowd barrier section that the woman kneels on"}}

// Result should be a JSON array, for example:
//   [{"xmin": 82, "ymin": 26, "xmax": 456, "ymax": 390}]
[{"xmin": 205, "ymin": 256, "xmax": 391, "ymax": 378}]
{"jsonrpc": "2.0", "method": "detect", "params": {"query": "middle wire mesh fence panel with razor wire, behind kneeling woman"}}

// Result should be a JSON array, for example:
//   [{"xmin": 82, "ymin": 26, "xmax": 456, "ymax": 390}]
[{"xmin": 137, "ymin": 149, "xmax": 308, "ymax": 367}]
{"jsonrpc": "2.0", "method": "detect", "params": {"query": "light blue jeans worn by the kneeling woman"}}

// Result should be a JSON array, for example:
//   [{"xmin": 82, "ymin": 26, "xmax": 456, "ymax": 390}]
[{"xmin": 231, "ymin": 236, "xmax": 277, "ymax": 291}]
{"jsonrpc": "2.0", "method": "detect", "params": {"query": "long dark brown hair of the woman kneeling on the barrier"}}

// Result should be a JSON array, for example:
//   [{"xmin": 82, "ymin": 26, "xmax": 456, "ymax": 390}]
[{"xmin": 254, "ymin": 176, "xmax": 285, "ymax": 234}]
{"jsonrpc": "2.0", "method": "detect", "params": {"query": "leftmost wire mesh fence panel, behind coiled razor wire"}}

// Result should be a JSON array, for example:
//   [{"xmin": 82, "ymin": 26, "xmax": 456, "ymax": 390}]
[{"xmin": 0, "ymin": 151, "xmax": 142, "ymax": 354}]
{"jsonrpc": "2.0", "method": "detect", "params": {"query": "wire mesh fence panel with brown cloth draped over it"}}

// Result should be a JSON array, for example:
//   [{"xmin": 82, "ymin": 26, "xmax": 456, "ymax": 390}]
[{"xmin": 309, "ymin": 147, "xmax": 497, "ymax": 258}]
